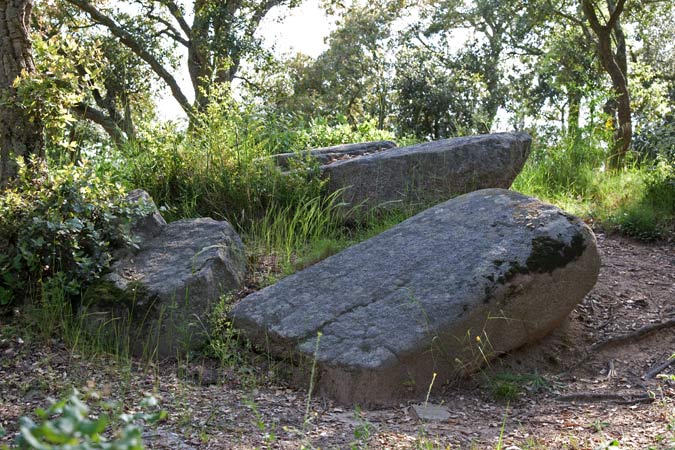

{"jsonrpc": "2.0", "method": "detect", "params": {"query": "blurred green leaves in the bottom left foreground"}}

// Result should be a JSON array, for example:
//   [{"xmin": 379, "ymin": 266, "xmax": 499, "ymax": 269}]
[{"xmin": 5, "ymin": 391, "xmax": 167, "ymax": 450}]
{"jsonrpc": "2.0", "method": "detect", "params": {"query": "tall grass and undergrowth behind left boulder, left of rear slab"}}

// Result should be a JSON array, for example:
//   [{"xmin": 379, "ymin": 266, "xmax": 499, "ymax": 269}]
[{"xmin": 93, "ymin": 92, "xmax": 412, "ymax": 278}]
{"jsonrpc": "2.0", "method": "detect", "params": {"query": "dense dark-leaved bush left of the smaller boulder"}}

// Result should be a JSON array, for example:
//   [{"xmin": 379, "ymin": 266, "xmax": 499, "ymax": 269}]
[{"xmin": 0, "ymin": 161, "xmax": 142, "ymax": 304}]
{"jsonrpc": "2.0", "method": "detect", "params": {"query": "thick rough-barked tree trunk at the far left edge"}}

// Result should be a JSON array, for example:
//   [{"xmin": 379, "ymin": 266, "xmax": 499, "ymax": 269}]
[{"xmin": 0, "ymin": 0, "xmax": 44, "ymax": 186}]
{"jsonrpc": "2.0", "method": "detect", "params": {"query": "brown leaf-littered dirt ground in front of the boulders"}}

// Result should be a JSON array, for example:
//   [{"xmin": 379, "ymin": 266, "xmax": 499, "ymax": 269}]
[{"xmin": 0, "ymin": 234, "xmax": 675, "ymax": 450}]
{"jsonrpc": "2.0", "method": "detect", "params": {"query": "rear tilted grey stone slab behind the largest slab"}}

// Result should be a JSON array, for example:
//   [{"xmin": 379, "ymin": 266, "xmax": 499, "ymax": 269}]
[{"xmin": 321, "ymin": 133, "xmax": 532, "ymax": 216}]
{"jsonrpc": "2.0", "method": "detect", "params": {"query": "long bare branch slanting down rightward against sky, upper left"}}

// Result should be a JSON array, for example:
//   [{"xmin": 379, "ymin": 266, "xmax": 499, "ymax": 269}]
[{"xmin": 66, "ymin": 0, "xmax": 192, "ymax": 115}]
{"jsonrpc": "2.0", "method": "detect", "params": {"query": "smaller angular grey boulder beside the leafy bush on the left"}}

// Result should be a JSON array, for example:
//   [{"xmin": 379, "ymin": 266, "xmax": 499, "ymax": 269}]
[{"xmin": 87, "ymin": 218, "xmax": 246, "ymax": 357}]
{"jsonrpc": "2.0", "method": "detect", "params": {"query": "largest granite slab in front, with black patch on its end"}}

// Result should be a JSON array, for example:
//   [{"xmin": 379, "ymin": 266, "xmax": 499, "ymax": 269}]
[{"xmin": 231, "ymin": 189, "xmax": 600, "ymax": 407}]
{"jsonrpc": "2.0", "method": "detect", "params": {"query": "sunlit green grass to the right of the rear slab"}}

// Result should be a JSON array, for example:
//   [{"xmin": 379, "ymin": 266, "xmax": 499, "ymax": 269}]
[{"xmin": 512, "ymin": 133, "xmax": 675, "ymax": 240}]
